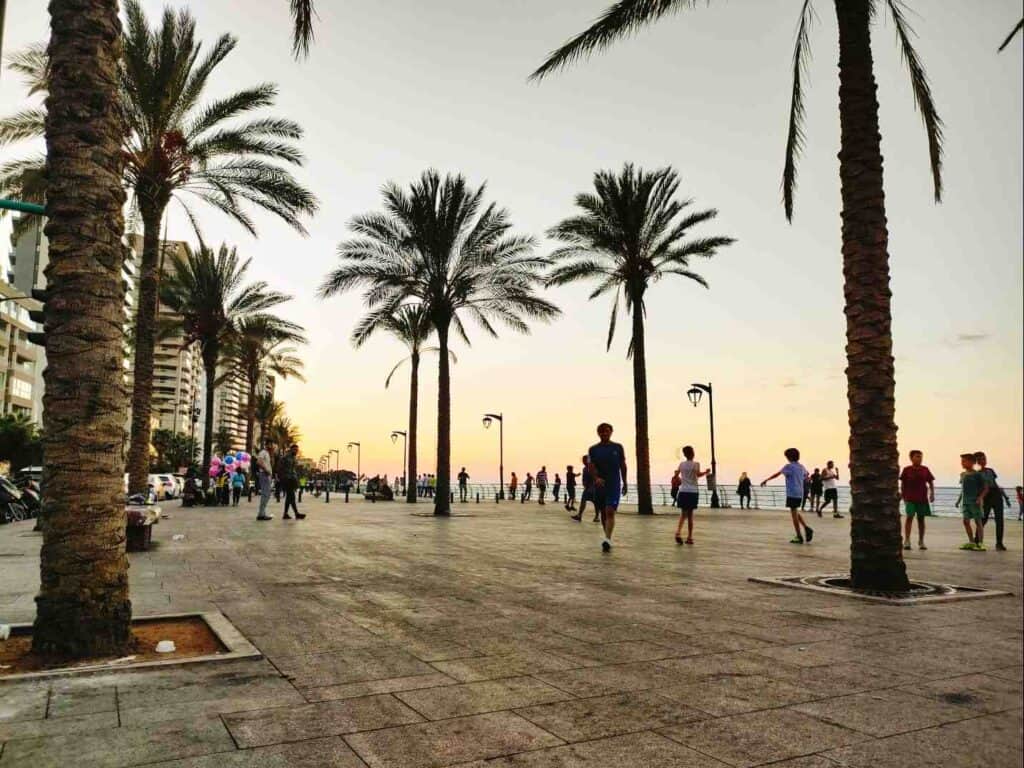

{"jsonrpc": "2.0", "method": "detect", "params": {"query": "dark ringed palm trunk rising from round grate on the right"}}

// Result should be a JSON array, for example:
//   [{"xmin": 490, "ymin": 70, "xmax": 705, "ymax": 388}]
[{"xmin": 836, "ymin": 0, "xmax": 908, "ymax": 590}]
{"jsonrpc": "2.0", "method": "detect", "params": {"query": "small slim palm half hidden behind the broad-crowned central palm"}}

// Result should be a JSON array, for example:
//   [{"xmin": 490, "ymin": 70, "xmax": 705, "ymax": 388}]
[{"xmin": 352, "ymin": 304, "xmax": 455, "ymax": 504}]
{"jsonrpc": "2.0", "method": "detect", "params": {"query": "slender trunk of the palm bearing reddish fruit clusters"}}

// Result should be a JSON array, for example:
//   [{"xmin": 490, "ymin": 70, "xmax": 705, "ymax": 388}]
[{"xmin": 128, "ymin": 200, "xmax": 163, "ymax": 494}]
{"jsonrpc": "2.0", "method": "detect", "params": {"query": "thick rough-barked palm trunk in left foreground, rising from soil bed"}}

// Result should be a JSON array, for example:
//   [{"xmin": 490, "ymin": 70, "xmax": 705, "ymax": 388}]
[{"xmin": 32, "ymin": 0, "xmax": 131, "ymax": 657}]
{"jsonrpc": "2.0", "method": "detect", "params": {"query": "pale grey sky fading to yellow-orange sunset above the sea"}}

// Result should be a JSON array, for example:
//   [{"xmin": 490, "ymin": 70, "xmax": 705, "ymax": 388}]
[{"xmin": 0, "ymin": 0, "xmax": 1024, "ymax": 484}]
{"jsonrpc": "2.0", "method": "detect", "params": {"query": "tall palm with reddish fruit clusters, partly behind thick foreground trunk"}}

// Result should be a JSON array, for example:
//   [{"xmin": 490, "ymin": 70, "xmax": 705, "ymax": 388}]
[{"xmin": 0, "ymin": 0, "xmax": 316, "ymax": 499}]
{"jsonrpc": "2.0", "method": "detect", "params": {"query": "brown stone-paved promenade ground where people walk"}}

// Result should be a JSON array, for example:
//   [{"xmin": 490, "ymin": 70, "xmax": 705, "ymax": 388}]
[{"xmin": 0, "ymin": 497, "xmax": 1024, "ymax": 768}]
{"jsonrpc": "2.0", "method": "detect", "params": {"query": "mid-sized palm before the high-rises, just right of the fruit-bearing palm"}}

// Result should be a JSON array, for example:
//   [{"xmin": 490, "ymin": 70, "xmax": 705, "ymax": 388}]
[{"xmin": 160, "ymin": 243, "xmax": 291, "ymax": 487}]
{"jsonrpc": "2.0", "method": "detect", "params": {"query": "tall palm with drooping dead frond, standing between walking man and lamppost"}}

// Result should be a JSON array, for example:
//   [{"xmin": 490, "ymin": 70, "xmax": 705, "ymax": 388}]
[{"xmin": 548, "ymin": 164, "xmax": 734, "ymax": 515}]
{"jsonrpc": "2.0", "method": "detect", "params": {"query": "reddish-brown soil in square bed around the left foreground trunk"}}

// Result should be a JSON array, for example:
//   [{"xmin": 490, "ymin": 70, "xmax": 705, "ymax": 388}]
[{"xmin": 0, "ymin": 616, "xmax": 227, "ymax": 679}]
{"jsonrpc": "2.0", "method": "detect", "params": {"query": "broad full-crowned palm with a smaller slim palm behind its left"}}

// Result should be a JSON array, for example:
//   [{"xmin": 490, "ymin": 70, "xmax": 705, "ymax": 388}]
[{"xmin": 319, "ymin": 170, "xmax": 558, "ymax": 515}]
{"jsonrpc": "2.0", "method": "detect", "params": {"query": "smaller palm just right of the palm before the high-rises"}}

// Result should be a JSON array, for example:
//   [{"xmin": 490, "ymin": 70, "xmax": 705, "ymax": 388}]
[{"xmin": 225, "ymin": 314, "xmax": 306, "ymax": 453}]
